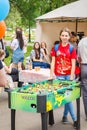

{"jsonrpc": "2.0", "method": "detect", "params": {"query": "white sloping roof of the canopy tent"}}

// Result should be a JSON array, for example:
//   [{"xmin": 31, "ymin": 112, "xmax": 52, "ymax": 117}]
[{"xmin": 36, "ymin": 0, "xmax": 87, "ymax": 20}]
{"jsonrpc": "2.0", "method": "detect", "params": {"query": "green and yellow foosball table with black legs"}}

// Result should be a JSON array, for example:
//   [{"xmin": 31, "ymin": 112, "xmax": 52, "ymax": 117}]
[{"xmin": 8, "ymin": 79, "xmax": 81, "ymax": 130}]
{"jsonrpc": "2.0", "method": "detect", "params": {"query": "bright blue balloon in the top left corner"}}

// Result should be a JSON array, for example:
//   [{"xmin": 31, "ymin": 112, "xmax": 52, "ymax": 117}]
[{"xmin": 0, "ymin": 0, "xmax": 10, "ymax": 21}]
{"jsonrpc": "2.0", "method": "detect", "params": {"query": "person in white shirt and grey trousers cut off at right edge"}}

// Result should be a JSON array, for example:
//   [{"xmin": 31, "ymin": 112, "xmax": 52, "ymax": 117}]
[{"xmin": 78, "ymin": 37, "xmax": 87, "ymax": 120}]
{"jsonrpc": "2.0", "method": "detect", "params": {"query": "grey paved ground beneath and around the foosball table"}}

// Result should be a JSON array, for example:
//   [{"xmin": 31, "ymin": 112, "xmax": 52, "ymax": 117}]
[{"xmin": 0, "ymin": 92, "xmax": 87, "ymax": 130}]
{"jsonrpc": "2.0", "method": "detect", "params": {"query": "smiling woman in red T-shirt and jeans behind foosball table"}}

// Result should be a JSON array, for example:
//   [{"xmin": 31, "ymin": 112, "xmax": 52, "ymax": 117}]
[{"xmin": 50, "ymin": 28, "xmax": 77, "ymax": 128}]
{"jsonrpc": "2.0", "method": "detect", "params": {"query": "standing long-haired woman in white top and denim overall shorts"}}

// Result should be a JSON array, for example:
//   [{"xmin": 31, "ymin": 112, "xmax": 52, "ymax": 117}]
[{"xmin": 11, "ymin": 26, "xmax": 24, "ymax": 70}]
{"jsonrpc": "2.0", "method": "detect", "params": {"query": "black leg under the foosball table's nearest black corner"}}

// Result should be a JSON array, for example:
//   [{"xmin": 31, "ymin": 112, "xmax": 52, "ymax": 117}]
[{"xmin": 41, "ymin": 112, "xmax": 48, "ymax": 130}]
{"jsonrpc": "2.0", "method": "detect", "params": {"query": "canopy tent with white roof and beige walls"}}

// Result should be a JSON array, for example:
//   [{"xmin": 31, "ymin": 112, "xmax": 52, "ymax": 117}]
[{"xmin": 36, "ymin": 0, "xmax": 87, "ymax": 49}]
